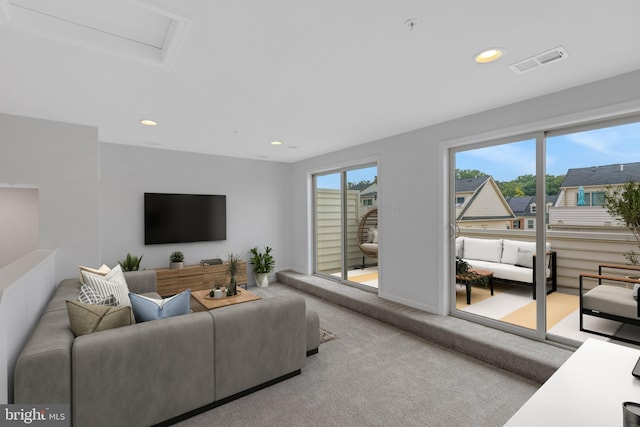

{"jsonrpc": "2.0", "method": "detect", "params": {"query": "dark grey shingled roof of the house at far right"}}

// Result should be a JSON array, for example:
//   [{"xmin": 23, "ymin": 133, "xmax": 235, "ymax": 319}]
[{"xmin": 561, "ymin": 162, "xmax": 640, "ymax": 188}]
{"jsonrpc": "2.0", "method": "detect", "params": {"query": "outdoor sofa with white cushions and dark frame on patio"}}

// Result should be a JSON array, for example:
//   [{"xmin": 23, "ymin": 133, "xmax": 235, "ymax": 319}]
[{"xmin": 456, "ymin": 236, "xmax": 557, "ymax": 299}]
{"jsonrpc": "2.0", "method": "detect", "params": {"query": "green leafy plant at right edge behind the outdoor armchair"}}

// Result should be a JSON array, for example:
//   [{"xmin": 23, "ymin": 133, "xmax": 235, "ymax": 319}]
[{"xmin": 604, "ymin": 181, "xmax": 640, "ymax": 265}]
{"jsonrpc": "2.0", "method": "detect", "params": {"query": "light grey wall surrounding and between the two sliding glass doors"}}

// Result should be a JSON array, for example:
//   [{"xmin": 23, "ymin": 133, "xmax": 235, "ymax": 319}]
[{"xmin": 291, "ymin": 71, "xmax": 640, "ymax": 314}]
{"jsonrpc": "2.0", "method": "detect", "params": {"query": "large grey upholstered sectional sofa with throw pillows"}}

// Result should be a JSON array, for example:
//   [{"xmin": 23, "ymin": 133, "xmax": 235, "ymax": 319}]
[{"xmin": 14, "ymin": 271, "xmax": 319, "ymax": 427}]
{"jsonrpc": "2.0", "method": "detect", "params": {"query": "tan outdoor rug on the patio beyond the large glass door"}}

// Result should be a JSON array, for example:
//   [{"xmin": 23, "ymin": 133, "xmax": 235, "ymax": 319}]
[{"xmin": 500, "ymin": 292, "xmax": 580, "ymax": 330}]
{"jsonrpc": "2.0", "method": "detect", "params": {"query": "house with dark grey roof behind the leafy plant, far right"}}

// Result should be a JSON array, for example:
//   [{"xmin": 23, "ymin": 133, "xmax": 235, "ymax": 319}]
[{"xmin": 549, "ymin": 162, "xmax": 640, "ymax": 230}]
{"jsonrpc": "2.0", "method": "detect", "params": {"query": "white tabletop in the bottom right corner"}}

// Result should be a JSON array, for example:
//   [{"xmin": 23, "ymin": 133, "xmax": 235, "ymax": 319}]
[{"xmin": 505, "ymin": 338, "xmax": 640, "ymax": 427}]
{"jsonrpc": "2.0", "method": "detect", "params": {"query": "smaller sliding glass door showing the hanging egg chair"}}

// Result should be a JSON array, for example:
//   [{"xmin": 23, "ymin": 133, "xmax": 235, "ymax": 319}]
[{"xmin": 313, "ymin": 165, "xmax": 379, "ymax": 291}]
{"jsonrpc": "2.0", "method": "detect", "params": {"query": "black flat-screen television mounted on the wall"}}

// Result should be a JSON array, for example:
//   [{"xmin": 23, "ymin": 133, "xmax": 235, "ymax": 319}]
[{"xmin": 144, "ymin": 193, "xmax": 227, "ymax": 245}]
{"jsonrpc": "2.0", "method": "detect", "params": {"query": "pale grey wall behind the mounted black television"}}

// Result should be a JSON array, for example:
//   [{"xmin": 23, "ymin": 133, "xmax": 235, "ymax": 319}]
[{"xmin": 100, "ymin": 143, "xmax": 293, "ymax": 280}]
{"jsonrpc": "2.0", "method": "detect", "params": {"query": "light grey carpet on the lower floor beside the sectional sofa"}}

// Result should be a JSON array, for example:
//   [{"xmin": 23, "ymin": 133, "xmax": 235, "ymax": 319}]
[{"xmin": 178, "ymin": 284, "xmax": 538, "ymax": 427}]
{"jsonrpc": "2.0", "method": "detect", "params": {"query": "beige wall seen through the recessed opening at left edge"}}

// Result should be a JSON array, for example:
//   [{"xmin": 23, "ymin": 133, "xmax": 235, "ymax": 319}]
[{"xmin": 0, "ymin": 188, "xmax": 39, "ymax": 268}]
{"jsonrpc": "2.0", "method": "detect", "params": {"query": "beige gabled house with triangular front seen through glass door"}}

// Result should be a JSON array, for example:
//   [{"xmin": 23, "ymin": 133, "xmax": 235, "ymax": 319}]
[{"xmin": 455, "ymin": 176, "xmax": 516, "ymax": 229}]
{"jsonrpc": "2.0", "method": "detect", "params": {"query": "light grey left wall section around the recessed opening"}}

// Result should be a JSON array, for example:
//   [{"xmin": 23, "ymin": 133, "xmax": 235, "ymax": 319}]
[{"xmin": 0, "ymin": 114, "xmax": 100, "ymax": 280}]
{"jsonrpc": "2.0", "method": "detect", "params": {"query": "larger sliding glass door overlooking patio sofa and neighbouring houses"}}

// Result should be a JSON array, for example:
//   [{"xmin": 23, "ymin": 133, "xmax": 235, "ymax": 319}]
[{"xmin": 449, "ymin": 116, "xmax": 640, "ymax": 345}]
